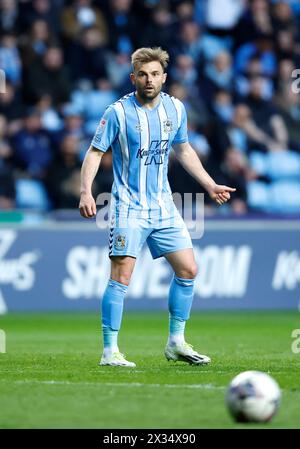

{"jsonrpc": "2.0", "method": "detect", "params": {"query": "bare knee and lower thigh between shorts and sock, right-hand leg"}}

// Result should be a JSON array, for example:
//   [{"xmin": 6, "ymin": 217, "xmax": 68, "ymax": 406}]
[{"xmin": 164, "ymin": 248, "xmax": 197, "ymax": 279}]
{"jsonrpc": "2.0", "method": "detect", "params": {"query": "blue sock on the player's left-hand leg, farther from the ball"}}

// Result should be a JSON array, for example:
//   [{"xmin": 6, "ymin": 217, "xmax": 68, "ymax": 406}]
[{"xmin": 101, "ymin": 279, "xmax": 128, "ymax": 351}]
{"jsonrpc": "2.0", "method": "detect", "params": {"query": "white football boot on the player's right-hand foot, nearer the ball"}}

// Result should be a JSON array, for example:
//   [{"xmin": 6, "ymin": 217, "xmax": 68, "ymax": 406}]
[{"xmin": 165, "ymin": 342, "xmax": 211, "ymax": 365}]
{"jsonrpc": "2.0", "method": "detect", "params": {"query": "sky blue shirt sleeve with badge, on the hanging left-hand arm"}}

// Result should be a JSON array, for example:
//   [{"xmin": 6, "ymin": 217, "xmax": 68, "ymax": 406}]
[{"xmin": 91, "ymin": 106, "xmax": 119, "ymax": 153}]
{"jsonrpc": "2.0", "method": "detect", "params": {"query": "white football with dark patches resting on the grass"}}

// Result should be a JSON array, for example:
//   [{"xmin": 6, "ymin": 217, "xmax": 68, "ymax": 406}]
[{"xmin": 226, "ymin": 371, "xmax": 281, "ymax": 423}]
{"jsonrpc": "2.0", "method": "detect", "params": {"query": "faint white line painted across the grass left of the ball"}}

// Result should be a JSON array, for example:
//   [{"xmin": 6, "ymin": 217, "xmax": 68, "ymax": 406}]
[{"xmin": 10, "ymin": 380, "xmax": 225, "ymax": 390}]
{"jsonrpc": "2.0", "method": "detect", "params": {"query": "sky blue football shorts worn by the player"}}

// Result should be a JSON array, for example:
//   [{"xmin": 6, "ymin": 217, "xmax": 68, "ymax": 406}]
[{"xmin": 109, "ymin": 213, "xmax": 193, "ymax": 259}]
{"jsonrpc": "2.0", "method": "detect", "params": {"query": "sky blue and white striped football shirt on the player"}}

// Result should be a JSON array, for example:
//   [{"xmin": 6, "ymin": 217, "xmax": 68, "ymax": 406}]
[{"xmin": 92, "ymin": 92, "xmax": 188, "ymax": 215}]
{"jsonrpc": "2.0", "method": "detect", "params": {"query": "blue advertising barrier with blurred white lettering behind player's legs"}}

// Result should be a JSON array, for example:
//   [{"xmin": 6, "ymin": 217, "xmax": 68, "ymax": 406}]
[{"xmin": 0, "ymin": 221, "xmax": 300, "ymax": 313}]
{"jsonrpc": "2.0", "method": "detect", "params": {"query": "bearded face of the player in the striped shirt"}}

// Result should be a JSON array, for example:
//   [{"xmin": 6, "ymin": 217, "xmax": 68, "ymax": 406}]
[{"xmin": 130, "ymin": 61, "xmax": 167, "ymax": 101}]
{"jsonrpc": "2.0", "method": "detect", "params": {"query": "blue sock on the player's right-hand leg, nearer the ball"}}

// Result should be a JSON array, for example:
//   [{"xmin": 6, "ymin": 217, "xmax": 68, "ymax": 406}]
[{"xmin": 169, "ymin": 276, "xmax": 195, "ymax": 344}]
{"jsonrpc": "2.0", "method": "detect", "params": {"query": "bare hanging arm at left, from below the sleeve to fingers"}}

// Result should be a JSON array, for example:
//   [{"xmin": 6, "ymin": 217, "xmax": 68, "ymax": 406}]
[{"xmin": 79, "ymin": 145, "xmax": 104, "ymax": 218}]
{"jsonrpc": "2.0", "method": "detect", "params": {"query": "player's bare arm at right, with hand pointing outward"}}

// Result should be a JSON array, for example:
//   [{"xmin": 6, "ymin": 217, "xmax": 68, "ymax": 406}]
[{"xmin": 173, "ymin": 142, "xmax": 236, "ymax": 204}]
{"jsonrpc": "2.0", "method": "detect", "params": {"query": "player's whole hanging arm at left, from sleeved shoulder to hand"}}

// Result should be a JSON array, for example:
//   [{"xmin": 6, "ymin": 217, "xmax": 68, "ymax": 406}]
[{"xmin": 79, "ymin": 106, "xmax": 119, "ymax": 218}]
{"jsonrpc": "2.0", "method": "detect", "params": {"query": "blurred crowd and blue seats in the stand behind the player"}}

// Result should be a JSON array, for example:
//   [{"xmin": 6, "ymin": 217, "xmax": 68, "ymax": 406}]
[{"xmin": 0, "ymin": 0, "xmax": 300, "ymax": 214}]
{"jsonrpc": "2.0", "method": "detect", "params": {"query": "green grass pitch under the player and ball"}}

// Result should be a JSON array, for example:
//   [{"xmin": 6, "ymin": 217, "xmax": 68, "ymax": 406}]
[{"xmin": 0, "ymin": 311, "xmax": 300, "ymax": 429}]
